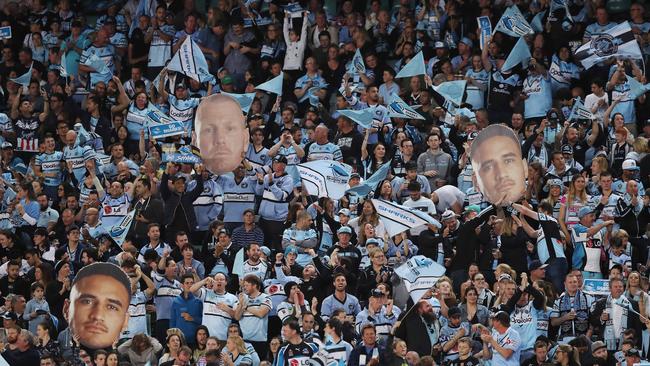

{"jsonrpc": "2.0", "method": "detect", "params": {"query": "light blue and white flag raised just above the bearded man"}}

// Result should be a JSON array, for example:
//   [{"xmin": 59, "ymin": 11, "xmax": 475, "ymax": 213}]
[{"xmin": 394, "ymin": 256, "xmax": 445, "ymax": 303}]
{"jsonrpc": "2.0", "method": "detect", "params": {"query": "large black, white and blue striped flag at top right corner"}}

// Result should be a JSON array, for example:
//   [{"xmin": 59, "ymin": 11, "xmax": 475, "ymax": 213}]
[{"xmin": 574, "ymin": 22, "xmax": 643, "ymax": 69}]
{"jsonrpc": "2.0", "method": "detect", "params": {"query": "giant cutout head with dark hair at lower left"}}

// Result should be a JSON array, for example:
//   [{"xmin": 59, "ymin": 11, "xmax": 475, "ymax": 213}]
[{"xmin": 63, "ymin": 262, "xmax": 131, "ymax": 350}]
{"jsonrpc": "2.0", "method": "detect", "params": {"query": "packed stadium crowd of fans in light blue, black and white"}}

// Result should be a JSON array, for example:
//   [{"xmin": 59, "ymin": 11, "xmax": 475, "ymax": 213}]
[{"xmin": 0, "ymin": 0, "xmax": 650, "ymax": 366}]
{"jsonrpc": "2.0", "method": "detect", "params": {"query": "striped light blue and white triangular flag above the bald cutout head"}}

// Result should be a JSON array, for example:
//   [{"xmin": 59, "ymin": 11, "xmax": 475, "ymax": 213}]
[{"xmin": 167, "ymin": 36, "xmax": 215, "ymax": 83}]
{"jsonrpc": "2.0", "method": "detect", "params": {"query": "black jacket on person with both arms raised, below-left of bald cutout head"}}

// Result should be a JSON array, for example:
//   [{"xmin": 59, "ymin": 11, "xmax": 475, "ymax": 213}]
[{"xmin": 160, "ymin": 172, "xmax": 203, "ymax": 230}]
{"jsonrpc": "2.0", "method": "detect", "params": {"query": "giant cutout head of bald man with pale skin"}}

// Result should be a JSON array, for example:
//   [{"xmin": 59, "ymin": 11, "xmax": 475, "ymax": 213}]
[{"xmin": 196, "ymin": 94, "xmax": 249, "ymax": 174}]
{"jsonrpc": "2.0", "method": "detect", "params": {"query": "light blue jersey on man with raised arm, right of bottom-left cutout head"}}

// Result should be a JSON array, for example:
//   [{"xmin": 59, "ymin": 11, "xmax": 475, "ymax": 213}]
[{"xmin": 198, "ymin": 288, "xmax": 239, "ymax": 341}]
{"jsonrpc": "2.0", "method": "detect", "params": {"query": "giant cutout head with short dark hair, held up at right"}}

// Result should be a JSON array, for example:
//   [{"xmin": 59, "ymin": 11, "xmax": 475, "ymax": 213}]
[{"xmin": 470, "ymin": 125, "xmax": 528, "ymax": 206}]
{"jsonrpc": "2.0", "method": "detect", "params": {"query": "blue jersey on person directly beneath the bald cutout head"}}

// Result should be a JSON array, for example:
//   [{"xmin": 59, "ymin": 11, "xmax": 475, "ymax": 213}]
[{"xmin": 216, "ymin": 175, "xmax": 262, "ymax": 222}]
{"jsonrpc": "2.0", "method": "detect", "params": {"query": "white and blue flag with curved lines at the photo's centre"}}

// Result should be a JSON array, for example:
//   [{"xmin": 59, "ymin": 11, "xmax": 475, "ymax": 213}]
[{"xmin": 298, "ymin": 160, "xmax": 352, "ymax": 200}]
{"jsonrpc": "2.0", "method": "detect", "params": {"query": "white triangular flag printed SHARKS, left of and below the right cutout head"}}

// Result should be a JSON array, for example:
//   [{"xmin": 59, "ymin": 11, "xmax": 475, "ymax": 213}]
[{"xmin": 372, "ymin": 198, "xmax": 442, "ymax": 237}]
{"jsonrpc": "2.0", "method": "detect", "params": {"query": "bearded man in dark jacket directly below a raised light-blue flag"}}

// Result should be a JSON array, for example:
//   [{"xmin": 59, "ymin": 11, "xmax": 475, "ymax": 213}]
[{"xmin": 393, "ymin": 289, "xmax": 441, "ymax": 355}]
